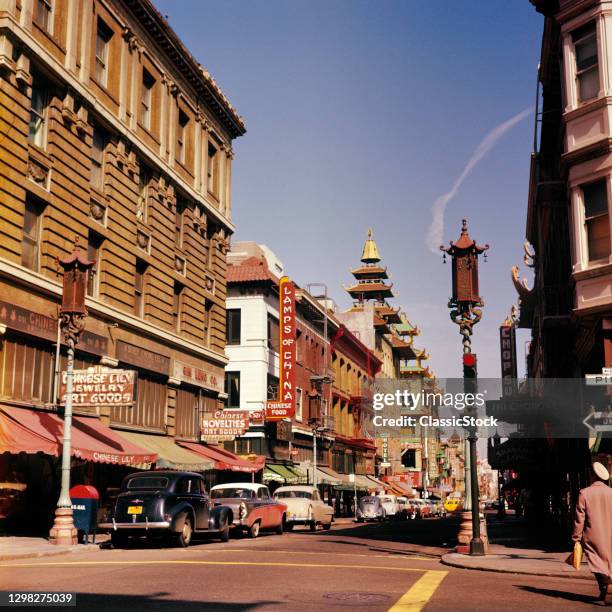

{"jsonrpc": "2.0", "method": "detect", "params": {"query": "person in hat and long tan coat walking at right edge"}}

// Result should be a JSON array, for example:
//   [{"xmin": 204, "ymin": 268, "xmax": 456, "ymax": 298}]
[{"xmin": 572, "ymin": 462, "xmax": 612, "ymax": 605}]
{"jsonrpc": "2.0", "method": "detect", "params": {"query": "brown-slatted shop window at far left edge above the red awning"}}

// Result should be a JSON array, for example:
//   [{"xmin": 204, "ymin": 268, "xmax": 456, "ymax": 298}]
[{"xmin": 0, "ymin": 335, "xmax": 54, "ymax": 404}]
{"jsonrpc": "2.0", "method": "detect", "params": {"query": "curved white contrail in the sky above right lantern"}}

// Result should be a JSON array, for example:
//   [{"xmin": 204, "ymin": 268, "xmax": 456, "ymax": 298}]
[{"xmin": 426, "ymin": 107, "xmax": 533, "ymax": 253}]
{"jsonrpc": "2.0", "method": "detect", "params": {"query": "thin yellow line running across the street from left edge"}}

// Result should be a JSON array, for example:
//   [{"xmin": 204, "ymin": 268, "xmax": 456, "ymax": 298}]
[{"xmin": 0, "ymin": 559, "xmax": 426, "ymax": 575}]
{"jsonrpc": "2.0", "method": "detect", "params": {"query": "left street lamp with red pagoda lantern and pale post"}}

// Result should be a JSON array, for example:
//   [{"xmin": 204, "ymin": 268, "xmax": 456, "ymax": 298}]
[{"xmin": 49, "ymin": 246, "xmax": 95, "ymax": 545}]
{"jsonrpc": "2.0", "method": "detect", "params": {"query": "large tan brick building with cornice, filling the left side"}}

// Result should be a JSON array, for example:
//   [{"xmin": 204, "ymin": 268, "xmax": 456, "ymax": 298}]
[{"xmin": 0, "ymin": 0, "xmax": 245, "ymax": 532}]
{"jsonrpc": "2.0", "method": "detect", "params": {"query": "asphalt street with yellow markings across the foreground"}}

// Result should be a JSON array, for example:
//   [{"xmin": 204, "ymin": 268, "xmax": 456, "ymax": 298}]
[{"xmin": 0, "ymin": 519, "xmax": 596, "ymax": 612}]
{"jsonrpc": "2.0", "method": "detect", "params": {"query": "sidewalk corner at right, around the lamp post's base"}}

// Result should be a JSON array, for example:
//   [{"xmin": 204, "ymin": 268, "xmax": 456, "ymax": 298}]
[{"xmin": 441, "ymin": 515, "xmax": 593, "ymax": 580}]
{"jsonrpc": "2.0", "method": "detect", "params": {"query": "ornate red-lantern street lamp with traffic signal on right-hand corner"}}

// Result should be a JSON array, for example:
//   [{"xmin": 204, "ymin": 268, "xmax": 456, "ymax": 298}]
[{"xmin": 440, "ymin": 219, "xmax": 489, "ymax": 555}]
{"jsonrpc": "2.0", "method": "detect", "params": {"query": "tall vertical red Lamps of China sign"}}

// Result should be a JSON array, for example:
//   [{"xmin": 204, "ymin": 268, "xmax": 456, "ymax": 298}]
[{"xmin": 266, "ymin": 276, "xmax": 296, "ymax": 421}]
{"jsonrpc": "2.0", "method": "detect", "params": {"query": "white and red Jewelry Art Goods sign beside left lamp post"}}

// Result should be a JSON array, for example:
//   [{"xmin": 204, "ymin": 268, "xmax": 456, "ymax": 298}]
[{"xmin": 60, "ymin": 367, "xmax": 136, "ymax": 406}]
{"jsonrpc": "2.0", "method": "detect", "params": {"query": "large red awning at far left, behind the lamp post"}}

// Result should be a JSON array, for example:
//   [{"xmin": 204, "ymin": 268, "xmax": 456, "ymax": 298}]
[{"xmin": 0, "ymin": 406, "xmax": 157, "ymax": 466}]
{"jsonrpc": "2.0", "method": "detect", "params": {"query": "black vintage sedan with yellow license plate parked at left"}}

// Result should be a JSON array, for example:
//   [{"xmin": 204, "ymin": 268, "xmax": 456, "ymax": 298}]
[{"xmin": 99, "ymin": 470, "xmax": 233, "ymax": 546}]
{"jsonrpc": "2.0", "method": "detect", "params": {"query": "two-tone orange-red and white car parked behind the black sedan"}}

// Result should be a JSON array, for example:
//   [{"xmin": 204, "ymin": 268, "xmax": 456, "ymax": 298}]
[{"xmin": 210, "ymin": 482, "xmax": 287, "ymax": 538}]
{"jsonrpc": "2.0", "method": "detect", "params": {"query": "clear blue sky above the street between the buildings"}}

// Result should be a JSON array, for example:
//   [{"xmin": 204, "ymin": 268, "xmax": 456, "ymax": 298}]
[{"xmin": 155, "ymin": 0, "xmax": 542, "ymax": 377}]
